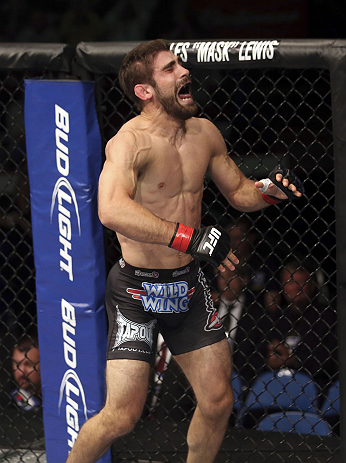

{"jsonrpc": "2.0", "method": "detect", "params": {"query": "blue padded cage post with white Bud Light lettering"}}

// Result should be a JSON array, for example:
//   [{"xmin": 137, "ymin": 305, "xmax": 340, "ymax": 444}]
[{"xmin": 25, "ymin": 80, "xmax": 111, "ymax": 463}]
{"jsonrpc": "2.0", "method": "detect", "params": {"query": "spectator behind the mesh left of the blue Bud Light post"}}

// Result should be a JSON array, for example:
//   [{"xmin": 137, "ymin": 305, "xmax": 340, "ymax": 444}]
[{"xmin": 11, "ymin": 335, "xmax": 41, "ymax": 411}]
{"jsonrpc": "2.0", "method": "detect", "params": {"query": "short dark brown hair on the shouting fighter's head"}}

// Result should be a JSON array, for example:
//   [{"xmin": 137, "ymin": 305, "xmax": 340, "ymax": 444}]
[{"xmin": 119, "ymin": 39, "xmax": 169, "ymax": 110}]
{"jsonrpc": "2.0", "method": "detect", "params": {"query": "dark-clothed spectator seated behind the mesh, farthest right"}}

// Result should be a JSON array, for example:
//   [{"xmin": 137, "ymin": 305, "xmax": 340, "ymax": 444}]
[{"xmin": 259, "ymin": 261, "xmax": 338, "ymax": 398}]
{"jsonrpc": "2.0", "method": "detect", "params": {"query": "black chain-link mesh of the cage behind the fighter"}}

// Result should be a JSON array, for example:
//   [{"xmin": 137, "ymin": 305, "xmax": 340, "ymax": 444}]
[{"xmin": 0, "ymin": 60, "xmax": 340, "ymax": 463}]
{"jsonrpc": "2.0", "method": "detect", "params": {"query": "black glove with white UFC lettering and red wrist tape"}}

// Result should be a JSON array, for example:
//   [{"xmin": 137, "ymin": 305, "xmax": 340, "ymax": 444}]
[{"xmin": 168, "ymin": 223, "xmax": 231, "ymax": 267}]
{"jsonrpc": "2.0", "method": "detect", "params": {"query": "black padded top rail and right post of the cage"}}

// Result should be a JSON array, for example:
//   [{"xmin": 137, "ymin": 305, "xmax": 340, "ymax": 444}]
[{"xmin": 0, "ymin": 39, "xmax": 346, "ymax": 460}]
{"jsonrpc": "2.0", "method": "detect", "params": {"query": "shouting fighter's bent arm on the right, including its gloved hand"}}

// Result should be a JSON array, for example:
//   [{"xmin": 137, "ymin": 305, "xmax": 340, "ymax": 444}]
[{"xmin": 208, "ymin": 121, "xmax": 304, "ymax": 212}]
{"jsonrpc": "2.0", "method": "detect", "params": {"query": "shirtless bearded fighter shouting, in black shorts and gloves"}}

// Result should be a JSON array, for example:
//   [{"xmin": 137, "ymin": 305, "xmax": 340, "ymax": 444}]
[{"xmin": 67, "ymin": 40, "xmax": 301, "ymax": 463}]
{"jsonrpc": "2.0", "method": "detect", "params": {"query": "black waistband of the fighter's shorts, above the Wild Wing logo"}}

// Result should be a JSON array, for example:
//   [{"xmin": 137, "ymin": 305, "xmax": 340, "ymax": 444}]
[{"xmin": 118, "ymin": 258, "xmax": 199, "ymax": 281}]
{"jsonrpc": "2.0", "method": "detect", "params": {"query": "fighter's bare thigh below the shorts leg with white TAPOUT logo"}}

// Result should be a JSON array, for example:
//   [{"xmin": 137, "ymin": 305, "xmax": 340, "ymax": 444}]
[{"xmin": 106, "ymin": 359, "xmax": 150, "ymax": 413}]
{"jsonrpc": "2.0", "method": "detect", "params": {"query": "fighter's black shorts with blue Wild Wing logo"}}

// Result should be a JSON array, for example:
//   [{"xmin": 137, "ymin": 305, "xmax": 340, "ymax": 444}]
[{"xmin": 106, "ymin": 259, "xmax": 225, "ymax": 363}]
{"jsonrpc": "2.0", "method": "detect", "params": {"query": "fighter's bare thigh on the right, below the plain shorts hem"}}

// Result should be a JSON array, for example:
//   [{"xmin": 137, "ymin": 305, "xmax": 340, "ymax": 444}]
[{"xmin": 175, "ymin": 339, "xmax": 232, "ymax": 401}]
